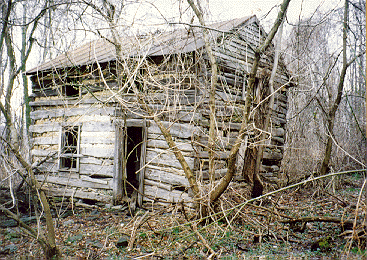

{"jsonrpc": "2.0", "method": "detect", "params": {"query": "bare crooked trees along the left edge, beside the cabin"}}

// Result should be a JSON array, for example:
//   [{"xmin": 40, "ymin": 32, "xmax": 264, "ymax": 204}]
[{"xmin": 0, "ymin": 0, "xmax": 58, "ymax": 259}]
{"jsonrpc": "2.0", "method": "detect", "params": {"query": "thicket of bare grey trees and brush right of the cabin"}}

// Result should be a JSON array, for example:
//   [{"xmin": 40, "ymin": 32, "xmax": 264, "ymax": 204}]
[{"xmin": 284, "ymin": 0, "xmax": 366, "ymax": 181}]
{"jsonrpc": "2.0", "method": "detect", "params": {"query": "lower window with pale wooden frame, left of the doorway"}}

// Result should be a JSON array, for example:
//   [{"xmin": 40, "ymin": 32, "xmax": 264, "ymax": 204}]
[{"xmin": 59, "ymin": 126, "xmax": 80, "ymax": 171}]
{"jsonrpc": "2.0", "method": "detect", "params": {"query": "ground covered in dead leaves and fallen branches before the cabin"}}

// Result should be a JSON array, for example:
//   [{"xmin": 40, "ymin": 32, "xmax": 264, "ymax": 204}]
[{"xmin": 0, "ymin": 172, "xmax": 366, "ymax": 259}]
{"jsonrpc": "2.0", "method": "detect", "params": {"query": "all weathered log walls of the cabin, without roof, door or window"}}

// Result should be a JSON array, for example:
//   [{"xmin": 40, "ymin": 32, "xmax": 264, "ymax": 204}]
[{"xmin": 30, "ymin": 15, "xmax": 294, "ymax": 205}]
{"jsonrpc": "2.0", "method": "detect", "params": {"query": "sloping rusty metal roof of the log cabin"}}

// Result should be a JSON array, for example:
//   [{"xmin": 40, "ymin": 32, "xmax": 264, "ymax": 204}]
[{"xmin": 26, "ymin": 16, "xmax": 257, "ymax": 75}]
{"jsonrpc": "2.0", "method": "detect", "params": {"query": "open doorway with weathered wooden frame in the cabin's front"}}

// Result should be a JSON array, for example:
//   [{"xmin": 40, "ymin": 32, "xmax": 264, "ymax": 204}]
[{"xmin": 113, "ymin": 119, "xmax": 147, "ymax": 206}]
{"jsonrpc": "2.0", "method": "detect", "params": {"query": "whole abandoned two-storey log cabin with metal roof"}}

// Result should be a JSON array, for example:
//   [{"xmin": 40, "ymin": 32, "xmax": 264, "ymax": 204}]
[{"xmin": 27, "ymin": 16, "xmax": 291, "ymax": 205}]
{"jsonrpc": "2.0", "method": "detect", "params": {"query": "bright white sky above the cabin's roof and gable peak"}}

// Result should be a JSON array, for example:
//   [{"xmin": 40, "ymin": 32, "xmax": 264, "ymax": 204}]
[{"xmin": 129, "ymin": 0, "xmax": 344, "ymax": 29}]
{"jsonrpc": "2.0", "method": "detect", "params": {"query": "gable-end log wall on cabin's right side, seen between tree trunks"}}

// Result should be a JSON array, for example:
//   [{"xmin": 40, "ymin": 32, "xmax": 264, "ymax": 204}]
[{"xmin": 199, "ymin": 16, "xmax": 290, "ymax": 185}]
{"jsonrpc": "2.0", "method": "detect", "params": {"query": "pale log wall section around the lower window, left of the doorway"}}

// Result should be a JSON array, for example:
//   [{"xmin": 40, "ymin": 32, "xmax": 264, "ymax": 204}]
[{"xmin": 30, "ymin": 100, "xmax": 116, "ymax": 202}]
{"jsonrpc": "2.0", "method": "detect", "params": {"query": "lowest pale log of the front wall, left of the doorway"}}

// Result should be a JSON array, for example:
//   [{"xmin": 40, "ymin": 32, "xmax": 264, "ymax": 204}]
[{"xmin": 42, "ymin": 187, "xmax": 112, "ymax": 203}]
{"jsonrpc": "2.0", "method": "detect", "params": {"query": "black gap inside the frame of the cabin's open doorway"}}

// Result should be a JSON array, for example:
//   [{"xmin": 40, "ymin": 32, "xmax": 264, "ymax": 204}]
[{"xmin": 126, "ymin": 127, "xmax": 143, "ymax": 197}]
